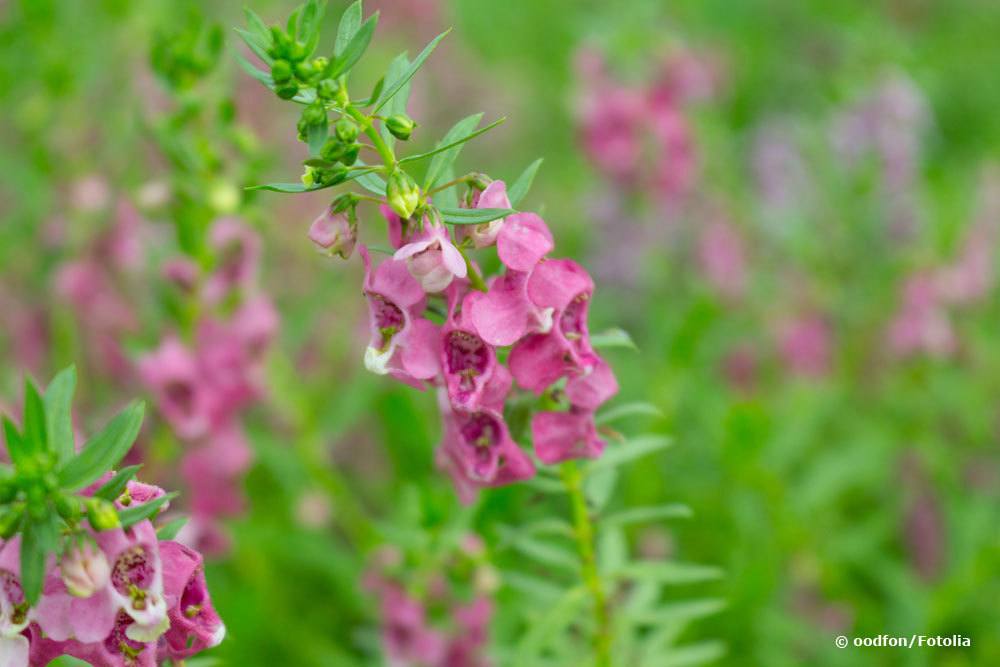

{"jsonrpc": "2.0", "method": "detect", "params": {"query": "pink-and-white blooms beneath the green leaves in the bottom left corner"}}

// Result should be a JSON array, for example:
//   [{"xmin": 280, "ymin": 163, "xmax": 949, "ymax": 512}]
[{"xmin": 6, "ymin": 486, "xmax": 225, "ymax": 667}]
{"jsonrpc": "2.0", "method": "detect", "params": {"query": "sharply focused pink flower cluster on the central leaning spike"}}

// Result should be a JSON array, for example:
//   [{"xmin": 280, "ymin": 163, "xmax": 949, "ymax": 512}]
[{"xmin": 352, "ymin": 181, "xmax": 618, "ymax": 500}]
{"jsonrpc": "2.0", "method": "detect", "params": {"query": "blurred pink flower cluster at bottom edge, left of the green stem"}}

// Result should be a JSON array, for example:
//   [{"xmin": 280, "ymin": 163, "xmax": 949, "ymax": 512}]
[{"xmin": 365, "ymin": 535, "xmax": 495, "ymax": 667}]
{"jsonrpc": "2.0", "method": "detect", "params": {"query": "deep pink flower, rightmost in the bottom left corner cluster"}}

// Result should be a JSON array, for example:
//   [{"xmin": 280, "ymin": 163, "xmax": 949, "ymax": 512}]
[{"xmin": 159, "ymin": 542, "xmax": 226, "ymax": 660}]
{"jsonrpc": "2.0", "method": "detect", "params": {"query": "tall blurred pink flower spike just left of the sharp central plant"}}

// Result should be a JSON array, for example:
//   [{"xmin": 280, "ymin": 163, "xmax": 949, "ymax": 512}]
[{"xmin": 139, "ymin": 218, "xmax": 278, "ymax": 552}]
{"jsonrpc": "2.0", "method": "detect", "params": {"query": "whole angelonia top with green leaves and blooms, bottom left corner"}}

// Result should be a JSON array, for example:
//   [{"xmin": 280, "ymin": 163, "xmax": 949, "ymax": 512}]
[{"xmin": 0, "ymin": 367, "xmax": 225, "ymax": 667}]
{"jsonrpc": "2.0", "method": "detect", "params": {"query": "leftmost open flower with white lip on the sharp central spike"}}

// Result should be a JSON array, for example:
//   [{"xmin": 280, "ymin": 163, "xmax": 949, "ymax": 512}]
[{"xmin": 359, "ymin": 245, "xmax": 440, "ymax": 386}]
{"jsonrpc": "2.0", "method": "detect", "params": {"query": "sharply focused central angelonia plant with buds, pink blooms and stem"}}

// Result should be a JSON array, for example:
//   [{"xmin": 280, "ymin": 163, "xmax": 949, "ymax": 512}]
[{"xmin": 237, "ymin": 0, "xmax": 715, "ymax": 665}]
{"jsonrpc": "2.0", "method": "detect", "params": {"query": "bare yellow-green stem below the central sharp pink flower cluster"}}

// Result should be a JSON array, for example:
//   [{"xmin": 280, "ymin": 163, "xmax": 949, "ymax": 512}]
[{"xmin": 560, "ymin": 461, "xmax": 611, "ymax": 667}]
